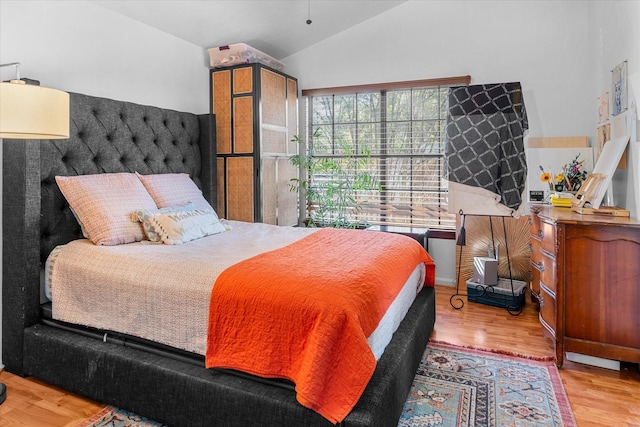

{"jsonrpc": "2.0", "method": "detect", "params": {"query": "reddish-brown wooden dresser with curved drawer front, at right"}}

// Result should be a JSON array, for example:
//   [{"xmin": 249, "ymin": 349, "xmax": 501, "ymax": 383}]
[{"xmin": 530, "ymin": 205, "xmax": 640, "ymax": 367}]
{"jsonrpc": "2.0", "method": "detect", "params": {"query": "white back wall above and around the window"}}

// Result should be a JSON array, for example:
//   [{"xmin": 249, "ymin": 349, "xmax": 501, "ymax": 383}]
[{"xmin": 282, "ymin": 0, "xmax": 640, "ymax": 284}]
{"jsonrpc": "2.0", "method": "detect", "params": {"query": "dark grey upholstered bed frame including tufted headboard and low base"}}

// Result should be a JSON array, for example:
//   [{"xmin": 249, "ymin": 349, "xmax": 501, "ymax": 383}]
[{"xmin": 2, "ymin": 93, "xmax": 435, "ymax": 427}]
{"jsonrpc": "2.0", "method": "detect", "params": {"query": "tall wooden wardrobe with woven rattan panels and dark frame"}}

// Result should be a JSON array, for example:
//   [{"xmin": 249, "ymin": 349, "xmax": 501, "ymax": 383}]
[{"xmin": 211, "ymin": 64, "xmax": 298, "ymax": 225}]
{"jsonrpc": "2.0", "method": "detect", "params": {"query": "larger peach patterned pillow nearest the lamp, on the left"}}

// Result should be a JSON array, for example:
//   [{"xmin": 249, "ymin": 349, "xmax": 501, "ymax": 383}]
[{"xmin": 56, "ymin": 173, "xmax": 157, "ymax": 245}]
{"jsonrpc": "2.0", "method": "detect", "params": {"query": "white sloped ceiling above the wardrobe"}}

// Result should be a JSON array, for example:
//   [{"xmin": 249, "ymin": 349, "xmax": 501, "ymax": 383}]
[{"xmin": 91, "ymin": 0, "xmax": 406, "ymax": 59}]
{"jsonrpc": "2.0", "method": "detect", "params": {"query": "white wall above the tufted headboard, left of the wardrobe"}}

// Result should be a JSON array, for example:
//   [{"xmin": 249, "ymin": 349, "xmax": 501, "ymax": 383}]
[{"xmin": 0, "ymin": 0, "xmax": 209, "ymax": 367}]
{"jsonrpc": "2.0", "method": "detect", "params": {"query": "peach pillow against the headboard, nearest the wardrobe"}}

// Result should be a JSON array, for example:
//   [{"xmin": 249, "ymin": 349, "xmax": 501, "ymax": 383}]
[{"xmin": 136, "ymin": 172, "xmax": 215, "ymax": 212}]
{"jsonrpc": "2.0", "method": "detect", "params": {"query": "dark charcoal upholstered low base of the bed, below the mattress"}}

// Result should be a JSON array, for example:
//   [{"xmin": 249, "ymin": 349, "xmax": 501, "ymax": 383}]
[{"xmin": 23, "ymin": 288, "xmax": 435, "ymax": 427}]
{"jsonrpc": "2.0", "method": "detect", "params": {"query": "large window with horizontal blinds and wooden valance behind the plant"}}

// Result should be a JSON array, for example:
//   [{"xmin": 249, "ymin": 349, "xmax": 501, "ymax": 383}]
[{"xmin": 302, "ymin": 76, "xmax": 470, "ymax": 230}]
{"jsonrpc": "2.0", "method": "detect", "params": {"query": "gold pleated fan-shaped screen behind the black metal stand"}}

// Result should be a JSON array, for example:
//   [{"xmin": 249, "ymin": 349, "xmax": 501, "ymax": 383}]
[{"xmin": 456, "ymin": 215, "xmax": 531, "ymax": 289}]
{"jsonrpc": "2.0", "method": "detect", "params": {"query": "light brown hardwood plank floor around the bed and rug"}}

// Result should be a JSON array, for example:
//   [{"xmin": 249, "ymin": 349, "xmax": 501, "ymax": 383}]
[{"xmin": 0, "ymin": 286, "xmax": 640, "ymax": 427}]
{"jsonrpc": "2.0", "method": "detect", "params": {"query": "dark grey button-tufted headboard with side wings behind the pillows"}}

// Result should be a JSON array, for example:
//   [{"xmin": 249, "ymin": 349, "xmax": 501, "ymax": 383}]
[{"xmin": 2, "ymin": 93, "xmax": 217, "ymax": 373}]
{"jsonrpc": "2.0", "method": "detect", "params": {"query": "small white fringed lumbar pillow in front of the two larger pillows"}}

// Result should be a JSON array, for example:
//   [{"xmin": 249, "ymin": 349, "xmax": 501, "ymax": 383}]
[{"xmin": 144, "ymin": 210, "xmax": 226, "ymax": 245}]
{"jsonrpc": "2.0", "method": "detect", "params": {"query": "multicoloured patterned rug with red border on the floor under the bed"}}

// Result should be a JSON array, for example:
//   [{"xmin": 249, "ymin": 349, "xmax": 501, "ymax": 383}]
[{"xmin": 79, "ymin": 342, "xmax": 577, "ymax": 427}]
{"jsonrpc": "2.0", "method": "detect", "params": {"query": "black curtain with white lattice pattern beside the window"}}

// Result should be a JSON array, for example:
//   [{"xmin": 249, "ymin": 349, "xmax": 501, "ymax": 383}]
[{"xmin": 445, "ymin": 82, "xmax": 528, "ymax": 214}]
